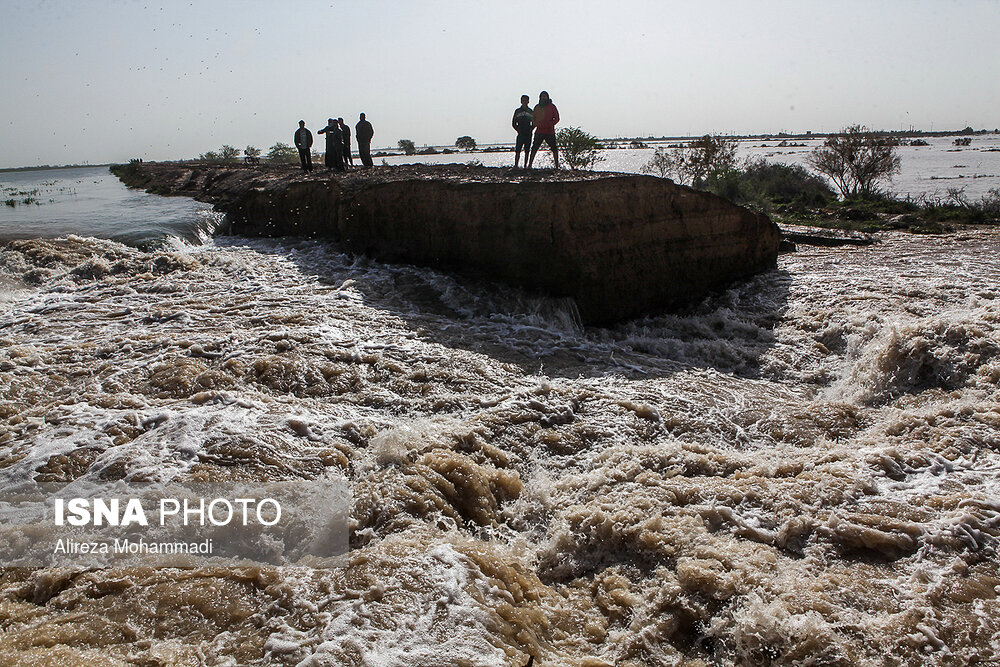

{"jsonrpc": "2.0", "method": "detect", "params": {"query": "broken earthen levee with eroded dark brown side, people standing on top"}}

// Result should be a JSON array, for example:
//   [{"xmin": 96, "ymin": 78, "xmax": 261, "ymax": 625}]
[{"xmin": 111, "ymin": 163, "xmax": 780, "ymax": 324}]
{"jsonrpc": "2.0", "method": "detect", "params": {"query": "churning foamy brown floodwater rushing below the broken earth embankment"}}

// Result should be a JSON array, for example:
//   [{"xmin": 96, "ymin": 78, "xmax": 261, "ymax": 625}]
[{"xmin": 0, "ymin": 167, "xmax": 1000, "ymax": 667}]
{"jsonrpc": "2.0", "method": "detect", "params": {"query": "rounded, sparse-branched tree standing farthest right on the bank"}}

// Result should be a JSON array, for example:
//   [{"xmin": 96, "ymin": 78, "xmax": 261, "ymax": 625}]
[{"xmin": 807, "ymin": 125, "xmax": 900, "ymax": 199}]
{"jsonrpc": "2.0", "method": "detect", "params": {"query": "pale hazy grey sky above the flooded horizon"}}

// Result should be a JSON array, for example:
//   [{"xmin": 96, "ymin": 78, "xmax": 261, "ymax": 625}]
[{"xmin": 0, "ymin": 0, "xmax": 1000, "ymax": 167}]
